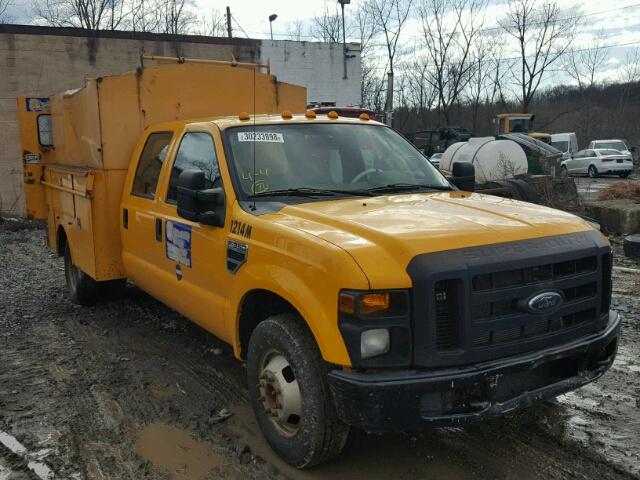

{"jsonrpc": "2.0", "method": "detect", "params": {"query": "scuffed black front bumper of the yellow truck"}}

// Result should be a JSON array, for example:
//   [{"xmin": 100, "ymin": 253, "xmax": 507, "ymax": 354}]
[{"xmin": 329, "ymin": 311, "xmax": 620, "ymax": 433}]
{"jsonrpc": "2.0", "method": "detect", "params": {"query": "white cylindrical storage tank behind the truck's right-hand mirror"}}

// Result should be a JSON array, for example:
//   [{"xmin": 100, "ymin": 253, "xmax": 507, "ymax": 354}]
[{"xmin": 440, "ymin": 137, "xmax": 528, "ymax": 183}]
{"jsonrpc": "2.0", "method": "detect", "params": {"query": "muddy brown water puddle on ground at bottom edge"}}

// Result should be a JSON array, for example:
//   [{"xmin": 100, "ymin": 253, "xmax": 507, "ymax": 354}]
[{"xmin": 135, "ymin": 423, "xmax": 224, "ymax": 480}]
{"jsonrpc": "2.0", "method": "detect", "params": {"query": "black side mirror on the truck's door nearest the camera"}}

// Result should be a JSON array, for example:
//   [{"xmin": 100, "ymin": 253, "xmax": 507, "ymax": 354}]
[{"xmin": 178, "ymin": 170, "xmax": 225, "ymax": 227}]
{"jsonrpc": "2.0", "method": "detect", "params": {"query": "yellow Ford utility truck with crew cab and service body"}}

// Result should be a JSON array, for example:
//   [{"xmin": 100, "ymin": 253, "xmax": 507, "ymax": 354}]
[{"xmin": 18, "ymin": 61, "xmax": 620, "ymax": 468}]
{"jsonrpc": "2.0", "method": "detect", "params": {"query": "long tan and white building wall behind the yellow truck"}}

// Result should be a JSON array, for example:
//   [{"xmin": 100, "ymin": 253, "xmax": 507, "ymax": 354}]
[{"xmin": 0, "ymin": 25, "xmax": 361, "ymax": 215}]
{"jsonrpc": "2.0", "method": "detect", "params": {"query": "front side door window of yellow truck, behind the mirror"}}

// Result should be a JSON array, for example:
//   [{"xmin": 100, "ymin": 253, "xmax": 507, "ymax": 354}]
[{"xmin": 167, "ymin": 132, "xmax": 220, "ymax": 203}]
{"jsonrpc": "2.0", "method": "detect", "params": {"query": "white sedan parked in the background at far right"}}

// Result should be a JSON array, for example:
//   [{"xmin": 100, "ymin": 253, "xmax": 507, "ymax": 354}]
[{"xmin": 560, "ymin": 148, "xmax": 633, "ymax": 178}]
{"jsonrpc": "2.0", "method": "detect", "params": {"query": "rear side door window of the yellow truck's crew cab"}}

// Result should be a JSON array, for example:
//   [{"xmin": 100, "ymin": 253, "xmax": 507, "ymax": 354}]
[{"xmin": 131, "ymin": 132, "xmax": 173, "ymax": 198}]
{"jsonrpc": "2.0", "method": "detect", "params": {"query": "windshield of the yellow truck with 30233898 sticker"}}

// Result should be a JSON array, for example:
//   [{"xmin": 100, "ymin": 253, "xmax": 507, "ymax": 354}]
[{"xmin": 225, "ymin": 123, "xmax": 451, "ymax": 198}]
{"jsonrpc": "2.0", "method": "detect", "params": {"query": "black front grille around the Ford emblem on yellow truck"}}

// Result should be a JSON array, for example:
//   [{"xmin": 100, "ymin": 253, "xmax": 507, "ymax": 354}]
[{"xmin": 408, "ymin": 230, "xmax": 611, "ymax": 367}]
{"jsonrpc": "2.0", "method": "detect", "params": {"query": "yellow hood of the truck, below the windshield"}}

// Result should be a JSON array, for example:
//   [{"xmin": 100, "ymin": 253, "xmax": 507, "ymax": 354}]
[{"xmin": 273, "ymin": 191, "xmax": 593, "ymax": 288}]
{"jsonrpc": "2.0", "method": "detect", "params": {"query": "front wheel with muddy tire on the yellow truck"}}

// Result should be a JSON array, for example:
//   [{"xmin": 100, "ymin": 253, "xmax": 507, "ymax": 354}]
[{"xmin": 247, "ymin": 315, "xmax": 349, "ymax": 468}]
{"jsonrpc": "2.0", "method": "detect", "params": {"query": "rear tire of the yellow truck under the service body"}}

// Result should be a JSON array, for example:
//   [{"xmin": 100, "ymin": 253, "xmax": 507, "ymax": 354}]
[{"xmin": 64, "ymin": 243, "xmax": 127, "ymax": 306}]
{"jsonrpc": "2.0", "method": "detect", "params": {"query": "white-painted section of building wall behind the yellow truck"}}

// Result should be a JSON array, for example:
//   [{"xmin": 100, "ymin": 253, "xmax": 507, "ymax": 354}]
[{"xmin": 260, "ymin": 40, "xmax": 362, "ymax": 107}]
